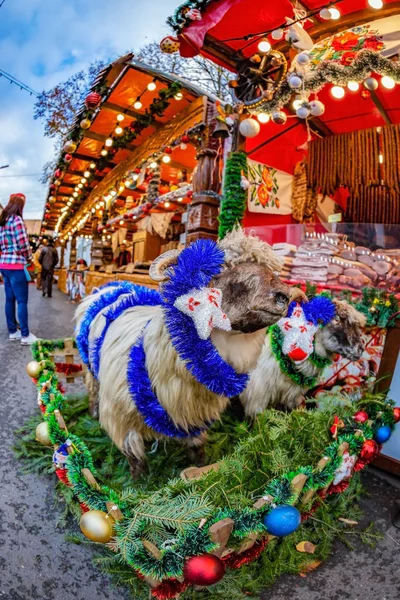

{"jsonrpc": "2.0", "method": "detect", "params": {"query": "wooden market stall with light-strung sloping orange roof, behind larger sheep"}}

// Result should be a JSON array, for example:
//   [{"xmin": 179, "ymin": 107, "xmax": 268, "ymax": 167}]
[{"xmin": 42, "ymin": 55, "xmax": 222, "ymax": 298}]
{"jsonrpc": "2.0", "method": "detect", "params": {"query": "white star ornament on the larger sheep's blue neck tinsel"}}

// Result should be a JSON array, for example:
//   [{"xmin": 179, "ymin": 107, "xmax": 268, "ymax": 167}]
[{"xmin": 174, "ymin": 288, "xmax": 232, "ymax": 340}]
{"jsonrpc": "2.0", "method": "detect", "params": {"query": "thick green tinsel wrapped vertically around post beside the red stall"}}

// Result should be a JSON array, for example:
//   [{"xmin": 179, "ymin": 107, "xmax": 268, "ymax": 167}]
[{"xmin": 218, "ymin": 152, "xmax": 247, "ymax": 239}]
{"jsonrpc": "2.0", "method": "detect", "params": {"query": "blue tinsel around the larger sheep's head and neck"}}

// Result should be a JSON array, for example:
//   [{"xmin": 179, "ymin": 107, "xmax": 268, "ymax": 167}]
[{"xmin": 161, "ymin": 240, "xmax": 248, "ymax": 398}]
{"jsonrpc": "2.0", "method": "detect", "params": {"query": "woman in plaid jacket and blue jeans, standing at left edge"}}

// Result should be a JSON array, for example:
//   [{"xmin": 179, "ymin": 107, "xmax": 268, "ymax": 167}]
[{"xmin": 0, "ymin": 194, "xmax": 38, "ymax": 346}]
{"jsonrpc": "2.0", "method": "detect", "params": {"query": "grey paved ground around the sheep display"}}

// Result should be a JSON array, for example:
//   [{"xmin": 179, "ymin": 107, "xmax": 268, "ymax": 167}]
[{"xmin": 0, "ymin": 286, "xmax": 400, "ymax": 600}]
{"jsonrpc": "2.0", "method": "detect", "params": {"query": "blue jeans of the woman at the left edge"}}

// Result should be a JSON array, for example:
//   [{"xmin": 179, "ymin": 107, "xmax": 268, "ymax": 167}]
[{"xmin": 0, "ymin": 269, "xmax": 29, "ymax": 337}]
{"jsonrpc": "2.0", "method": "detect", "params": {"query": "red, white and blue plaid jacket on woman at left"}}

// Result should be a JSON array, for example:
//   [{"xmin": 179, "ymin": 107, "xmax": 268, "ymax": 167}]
[{"xmin": 0, "ymin": 216, "xmax": 32, "ymax": 265}]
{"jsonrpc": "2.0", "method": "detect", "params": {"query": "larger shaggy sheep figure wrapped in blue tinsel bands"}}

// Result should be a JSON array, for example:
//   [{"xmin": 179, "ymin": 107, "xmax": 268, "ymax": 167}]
[{"xmin": 76, "ymin": 230, "xmax": 300, "ymax": 477}]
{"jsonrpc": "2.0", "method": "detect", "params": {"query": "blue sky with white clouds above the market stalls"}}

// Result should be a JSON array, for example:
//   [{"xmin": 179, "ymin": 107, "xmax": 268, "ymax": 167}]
[{"xmin": 0, "ymin": 0, "xmax": 181, "ymax": 219}]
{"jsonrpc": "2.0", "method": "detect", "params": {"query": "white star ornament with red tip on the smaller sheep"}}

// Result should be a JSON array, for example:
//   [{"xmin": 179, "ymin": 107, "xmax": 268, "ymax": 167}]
[{"xmin": 278, "ymin": 304, "xmax": 318, "ymax": 362}]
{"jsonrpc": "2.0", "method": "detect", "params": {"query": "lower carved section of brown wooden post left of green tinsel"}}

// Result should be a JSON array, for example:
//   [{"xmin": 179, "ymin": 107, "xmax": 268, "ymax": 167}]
[{"xmin": 186, "ymin": 148, "xmax": 221, "ymax": 244}]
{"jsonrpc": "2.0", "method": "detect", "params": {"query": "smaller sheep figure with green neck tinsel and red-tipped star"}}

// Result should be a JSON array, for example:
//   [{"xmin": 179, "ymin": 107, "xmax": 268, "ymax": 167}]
[{"xmin": 240, "ymin": 296, "xmax": 365, "ymax": 417}]
